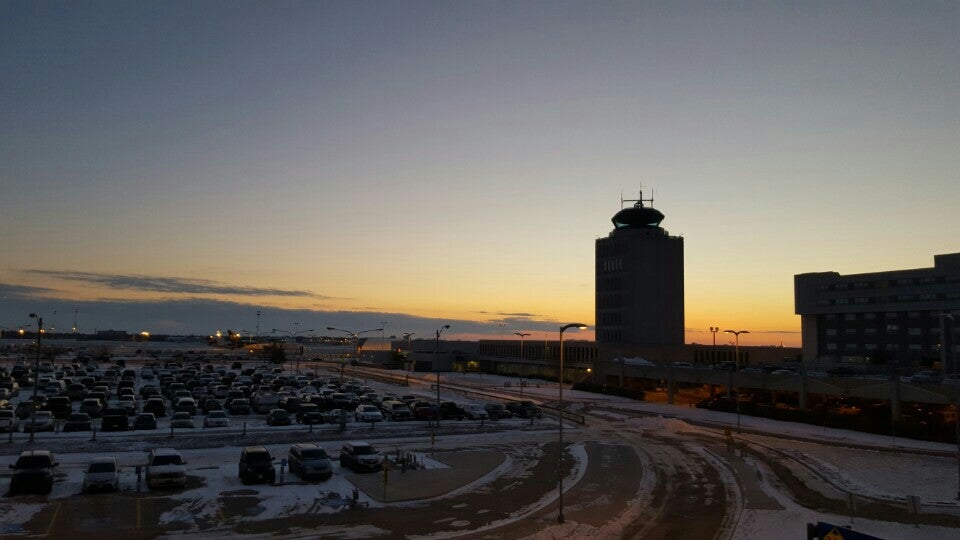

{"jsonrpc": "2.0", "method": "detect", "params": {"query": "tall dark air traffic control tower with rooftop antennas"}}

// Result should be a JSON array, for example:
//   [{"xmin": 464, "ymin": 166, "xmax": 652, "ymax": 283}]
[{"xmin": 595, "ymin": 192, "xmax": 684, "ymax": 347}]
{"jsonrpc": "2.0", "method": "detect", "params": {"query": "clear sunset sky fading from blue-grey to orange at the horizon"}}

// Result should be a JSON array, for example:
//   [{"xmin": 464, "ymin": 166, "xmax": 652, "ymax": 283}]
[{"xmin": 0, "ymin": 1, "xmax": 960, "ymax": 345}]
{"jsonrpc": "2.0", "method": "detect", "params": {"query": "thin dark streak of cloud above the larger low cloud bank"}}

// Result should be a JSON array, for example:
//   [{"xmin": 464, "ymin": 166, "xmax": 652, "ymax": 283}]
[{"xmin": 24, "ymin": 269, "xmax": 330, "ymax": 300}]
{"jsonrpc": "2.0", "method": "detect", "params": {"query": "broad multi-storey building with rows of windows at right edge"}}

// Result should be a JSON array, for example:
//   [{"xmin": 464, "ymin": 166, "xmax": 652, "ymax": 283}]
[{"xmin": 794, "ymin": 253, "xmax": 960, "ymax": 371}]
